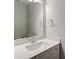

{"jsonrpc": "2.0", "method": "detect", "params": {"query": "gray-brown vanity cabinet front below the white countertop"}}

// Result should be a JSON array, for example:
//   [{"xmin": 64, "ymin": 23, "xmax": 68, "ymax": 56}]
[{"xmin": 31, "ymin": 45, "xmax": 59, "ymax": 59}]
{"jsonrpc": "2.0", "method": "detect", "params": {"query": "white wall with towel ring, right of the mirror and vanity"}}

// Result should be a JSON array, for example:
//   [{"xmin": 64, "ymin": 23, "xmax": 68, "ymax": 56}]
[{"xmin": 46, "ymin": 0, "xmax": 65, "ymax": 59}]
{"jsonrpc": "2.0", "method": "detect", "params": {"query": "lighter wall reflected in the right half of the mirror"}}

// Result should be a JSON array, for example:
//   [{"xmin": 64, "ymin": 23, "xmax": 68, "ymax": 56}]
[{"xmin": 27, "ymin": 3, "xmax": 43, "ymax": 36}]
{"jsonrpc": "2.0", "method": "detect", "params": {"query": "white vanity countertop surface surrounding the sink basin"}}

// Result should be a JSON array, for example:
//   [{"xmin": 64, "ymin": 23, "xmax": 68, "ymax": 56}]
[{"xmin": 14, "ymin": 39, "xmax": 60, "ymax": 59}]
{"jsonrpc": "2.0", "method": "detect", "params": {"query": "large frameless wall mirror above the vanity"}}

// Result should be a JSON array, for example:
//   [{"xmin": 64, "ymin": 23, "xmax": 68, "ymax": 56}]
[{"xmin": 14, "ymin": 0, "xmax": 43, "ymax": 39}]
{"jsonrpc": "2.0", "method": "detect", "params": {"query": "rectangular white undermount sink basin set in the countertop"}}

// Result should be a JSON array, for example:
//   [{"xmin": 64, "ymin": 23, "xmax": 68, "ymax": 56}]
[{"xmin": 25, "ymin": 41, "xmax": 49, "ymax": 51}]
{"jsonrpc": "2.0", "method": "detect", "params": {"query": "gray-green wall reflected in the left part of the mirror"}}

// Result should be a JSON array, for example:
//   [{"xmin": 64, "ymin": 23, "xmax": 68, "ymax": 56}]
[{"xmin": 14, "ymin": 1, "xmax": 27, "ymax": 38}]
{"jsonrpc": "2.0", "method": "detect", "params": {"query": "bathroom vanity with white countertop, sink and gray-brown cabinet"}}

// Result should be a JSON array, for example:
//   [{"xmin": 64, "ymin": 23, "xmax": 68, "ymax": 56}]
[{"xmin": 14, "ymin": 39, "xmax": 60, "ymax": 59}]
